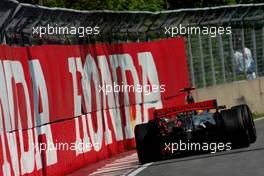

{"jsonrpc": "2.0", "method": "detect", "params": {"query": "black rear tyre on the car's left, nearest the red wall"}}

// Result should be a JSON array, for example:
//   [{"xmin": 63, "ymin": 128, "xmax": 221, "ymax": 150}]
[{"xmin": 135, "ymin": 120, "xmax": 160, "ymax": 164}]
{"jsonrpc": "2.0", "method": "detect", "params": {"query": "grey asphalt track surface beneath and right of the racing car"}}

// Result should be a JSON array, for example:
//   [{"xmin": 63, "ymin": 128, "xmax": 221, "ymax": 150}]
[{"xmin": 133, "ymin": 119, "xmax": 264, "ymax": 176}]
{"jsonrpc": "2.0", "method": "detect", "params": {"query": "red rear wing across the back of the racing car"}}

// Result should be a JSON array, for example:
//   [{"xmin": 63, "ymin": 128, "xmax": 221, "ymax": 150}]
[{"xmin": 154, "ymin": 100, "xmax": 217, "ymax": 118}]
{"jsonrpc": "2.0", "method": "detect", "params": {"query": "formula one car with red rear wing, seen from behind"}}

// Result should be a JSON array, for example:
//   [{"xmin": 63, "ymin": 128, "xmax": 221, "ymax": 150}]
[{"xmin": 135, "ymin": 88, "xmax": 256, "ymax": 164}]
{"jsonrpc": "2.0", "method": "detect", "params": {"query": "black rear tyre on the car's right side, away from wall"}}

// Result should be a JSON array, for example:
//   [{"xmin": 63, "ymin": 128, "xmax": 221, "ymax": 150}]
[{"xmin": 221, "ymin": 108, "xmax": 250, "ymax": 148}]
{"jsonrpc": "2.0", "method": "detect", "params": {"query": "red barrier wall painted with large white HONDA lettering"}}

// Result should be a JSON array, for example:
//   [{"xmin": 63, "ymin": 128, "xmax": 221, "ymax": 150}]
[{"xmin": 0, "ymin": 38, "xmax": 189, "ymax": 175}]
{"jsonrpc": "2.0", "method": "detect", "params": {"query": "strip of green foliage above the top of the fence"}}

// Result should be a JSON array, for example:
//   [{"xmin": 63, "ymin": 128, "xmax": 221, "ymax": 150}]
[{"xmin": 19, "ymin": 0, "xmax": 263, "ymax": 11}]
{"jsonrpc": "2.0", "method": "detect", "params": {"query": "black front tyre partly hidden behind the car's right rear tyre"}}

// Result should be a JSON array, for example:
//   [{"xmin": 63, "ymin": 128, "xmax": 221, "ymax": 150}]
[{"xmin": 232, "ymin": 104, "xmax": 257, "ymax": 143}]
